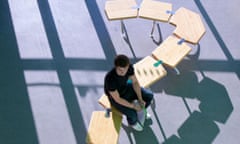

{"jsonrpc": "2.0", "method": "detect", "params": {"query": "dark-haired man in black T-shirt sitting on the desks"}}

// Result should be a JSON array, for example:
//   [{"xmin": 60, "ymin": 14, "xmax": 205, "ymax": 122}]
[{"xmin": 104, "ymin": 55, "xmax": 153, "ymax": 131}]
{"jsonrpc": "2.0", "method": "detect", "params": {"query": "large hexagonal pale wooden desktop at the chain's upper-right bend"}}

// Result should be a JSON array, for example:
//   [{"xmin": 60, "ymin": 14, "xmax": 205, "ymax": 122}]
[{"xmin": 169, "ymin": 7, "xmax": 206, "ymax": 44}]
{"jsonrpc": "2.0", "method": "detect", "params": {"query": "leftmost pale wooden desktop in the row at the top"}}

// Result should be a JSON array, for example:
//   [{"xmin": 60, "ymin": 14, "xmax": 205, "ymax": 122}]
[{"xmin": 105, "ymin": 0, "xmax": 138, "ymax": 20}]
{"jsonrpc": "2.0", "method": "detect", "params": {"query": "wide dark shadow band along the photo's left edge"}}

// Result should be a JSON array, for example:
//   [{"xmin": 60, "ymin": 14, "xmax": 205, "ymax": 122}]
[{"xmin": 0, "ymin": 1, "xmax": 39, "ymax": 144}]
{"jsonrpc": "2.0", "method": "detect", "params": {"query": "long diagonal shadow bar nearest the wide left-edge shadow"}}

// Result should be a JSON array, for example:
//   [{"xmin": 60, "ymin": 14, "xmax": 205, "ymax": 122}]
[{"xmin": 37, "ymin": 0, "xmax": 86, "ymax": 143}]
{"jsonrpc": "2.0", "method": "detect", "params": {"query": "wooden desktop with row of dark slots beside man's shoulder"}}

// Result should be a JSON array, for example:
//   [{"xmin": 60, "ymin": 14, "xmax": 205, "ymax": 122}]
[{"xmin": 134, "ymin": 56, "xmax": 167, "ymax": 87}]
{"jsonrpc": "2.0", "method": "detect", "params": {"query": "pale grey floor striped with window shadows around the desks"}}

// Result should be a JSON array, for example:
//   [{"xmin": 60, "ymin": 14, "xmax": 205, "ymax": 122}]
[{"xmin": 0, "ymin": 0, "xmax": 240, "ymax": 144}]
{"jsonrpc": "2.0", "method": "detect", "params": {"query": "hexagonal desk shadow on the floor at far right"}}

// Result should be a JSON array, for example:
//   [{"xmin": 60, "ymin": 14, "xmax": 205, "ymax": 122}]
[{"xmin": 195, "ymin": 77, "xmax": 233, "ymax": 123}]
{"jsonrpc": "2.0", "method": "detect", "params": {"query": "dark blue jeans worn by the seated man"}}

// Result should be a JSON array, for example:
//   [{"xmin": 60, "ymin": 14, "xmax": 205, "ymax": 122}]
[{"xmin": 108, "ymin": 84, "xmax": 153, "ymax": 125}]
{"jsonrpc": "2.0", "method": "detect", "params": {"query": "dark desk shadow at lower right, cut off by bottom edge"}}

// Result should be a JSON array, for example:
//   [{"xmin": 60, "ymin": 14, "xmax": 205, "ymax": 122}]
[{"xmin": 163, "ymin": 111, "xmax": 219, "ymax": 144}]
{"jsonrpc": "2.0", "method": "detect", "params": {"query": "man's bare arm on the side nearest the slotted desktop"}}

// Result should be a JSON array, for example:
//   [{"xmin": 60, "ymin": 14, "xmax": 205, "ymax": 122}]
[{"xmin": 129, "ymin": 75, "xmax": 146, "ymax": 106}]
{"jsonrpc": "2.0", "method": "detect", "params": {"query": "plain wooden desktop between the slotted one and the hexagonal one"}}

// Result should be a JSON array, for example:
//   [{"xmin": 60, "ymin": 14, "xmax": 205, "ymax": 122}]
[{"xmin": 152, "ymin": 36, "xmax": 191, "ymax": 67}]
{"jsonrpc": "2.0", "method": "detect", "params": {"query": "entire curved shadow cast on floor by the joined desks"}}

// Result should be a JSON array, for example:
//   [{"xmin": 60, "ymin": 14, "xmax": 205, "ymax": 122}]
[{"xmin": 152, "ymin": 69, "xmax": 233, "ymax": 144}]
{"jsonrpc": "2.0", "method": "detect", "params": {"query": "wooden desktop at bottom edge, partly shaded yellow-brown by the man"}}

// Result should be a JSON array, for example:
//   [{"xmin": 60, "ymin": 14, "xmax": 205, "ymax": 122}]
[{"xmin": 86, "ymin": 111, "xmax": 122, "ymax": 144}]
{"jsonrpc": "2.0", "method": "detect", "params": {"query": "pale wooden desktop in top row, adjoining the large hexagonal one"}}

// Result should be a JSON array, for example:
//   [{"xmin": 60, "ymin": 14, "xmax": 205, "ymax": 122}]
[{"xmin": 139, "ymin": 0, "xmax": 172, "ymax": 22}]
